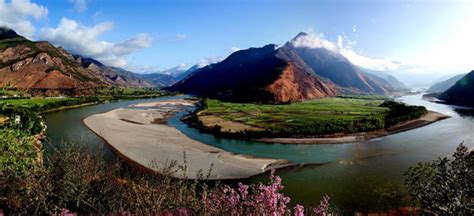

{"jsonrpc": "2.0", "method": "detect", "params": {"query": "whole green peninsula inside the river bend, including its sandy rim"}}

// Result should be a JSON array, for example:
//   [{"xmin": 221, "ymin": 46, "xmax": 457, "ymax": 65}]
[{"xmin": 184, "ymin": 96, "xmax": 449, "ymax": 144}]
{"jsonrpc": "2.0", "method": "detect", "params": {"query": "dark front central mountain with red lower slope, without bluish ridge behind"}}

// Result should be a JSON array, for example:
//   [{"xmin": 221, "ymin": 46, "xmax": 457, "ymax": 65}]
[{"xmin": 168, "ymin": 45, "xmax": 337, "ymax": 103}]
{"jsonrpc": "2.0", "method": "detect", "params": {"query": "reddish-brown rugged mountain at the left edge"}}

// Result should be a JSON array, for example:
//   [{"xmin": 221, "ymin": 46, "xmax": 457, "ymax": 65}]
[{"xmin": 0, "ymin": 27, "xmax": 149, "ymax": 96}]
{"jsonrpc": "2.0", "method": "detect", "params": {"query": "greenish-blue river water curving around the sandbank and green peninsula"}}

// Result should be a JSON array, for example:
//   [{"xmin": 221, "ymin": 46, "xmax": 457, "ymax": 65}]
[{"xmin": 45, "ymin": 94, "xmax": 474, "ymax": 210}]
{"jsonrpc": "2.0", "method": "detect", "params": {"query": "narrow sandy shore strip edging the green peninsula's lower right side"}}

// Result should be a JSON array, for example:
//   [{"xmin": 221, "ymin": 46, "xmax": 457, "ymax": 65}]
[{"xmin": 254, "ymin": 111, "xmax": 450, "ymax": 144}]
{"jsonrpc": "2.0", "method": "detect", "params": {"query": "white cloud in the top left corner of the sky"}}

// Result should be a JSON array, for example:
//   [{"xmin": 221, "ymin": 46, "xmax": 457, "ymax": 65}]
[{"xmin": 0, "ymin": 0, "xmax": 48, "ymax": 38}]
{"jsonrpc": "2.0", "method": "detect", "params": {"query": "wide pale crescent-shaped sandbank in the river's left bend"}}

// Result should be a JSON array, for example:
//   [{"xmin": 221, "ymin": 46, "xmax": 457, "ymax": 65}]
[{"xmin": 83, "ymin": 100, "xmax": 291, "ymax": 179}]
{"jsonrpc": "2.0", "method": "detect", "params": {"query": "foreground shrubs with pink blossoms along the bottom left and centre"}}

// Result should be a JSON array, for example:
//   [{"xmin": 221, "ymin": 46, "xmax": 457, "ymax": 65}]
[{"xmin": 0, "ymin": 141, "xmax": 329, "ymax": 215}]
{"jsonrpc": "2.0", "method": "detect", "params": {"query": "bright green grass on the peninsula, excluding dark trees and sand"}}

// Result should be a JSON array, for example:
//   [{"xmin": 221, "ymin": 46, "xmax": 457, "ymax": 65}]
[{"xmin": 201, "ymin": 98, "xmax": 388, "ymax": 128}]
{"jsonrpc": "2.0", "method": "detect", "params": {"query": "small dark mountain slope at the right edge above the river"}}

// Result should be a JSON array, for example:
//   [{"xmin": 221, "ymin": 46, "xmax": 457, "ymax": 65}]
[{"xmin": 439, "ymin": 70, "xmax": 474, "ymax": 107}]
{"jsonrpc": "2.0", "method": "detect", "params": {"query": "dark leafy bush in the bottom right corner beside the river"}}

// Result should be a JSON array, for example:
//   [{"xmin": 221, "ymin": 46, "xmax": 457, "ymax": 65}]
[{"xmin": 405, "ymin": 144, "xmax": 474, "ymax": 215}]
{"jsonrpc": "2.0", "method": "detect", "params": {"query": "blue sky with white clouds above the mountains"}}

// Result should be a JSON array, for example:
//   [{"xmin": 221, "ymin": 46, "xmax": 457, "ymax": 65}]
[{"xmin": 0, "ymin": 0, "xmax": 474, "ymax": 87}]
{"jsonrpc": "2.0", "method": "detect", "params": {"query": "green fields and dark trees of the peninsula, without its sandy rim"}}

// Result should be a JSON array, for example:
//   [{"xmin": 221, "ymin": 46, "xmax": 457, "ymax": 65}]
[{"xmin": 188, "ymin": 96, "xmax": 426, "ymax": 137}]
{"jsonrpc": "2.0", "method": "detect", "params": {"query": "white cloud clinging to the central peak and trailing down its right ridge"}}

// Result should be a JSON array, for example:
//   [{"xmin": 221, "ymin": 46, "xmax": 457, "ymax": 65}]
[{"xmin": 291, "ymin": 34, "xmax": 400, "ymax": 70}]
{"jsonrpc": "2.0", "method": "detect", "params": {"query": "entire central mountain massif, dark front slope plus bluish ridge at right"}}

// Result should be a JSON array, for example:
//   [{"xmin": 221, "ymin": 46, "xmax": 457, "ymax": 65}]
[{"xmin": 168, "ymin": 33, "xmax": 404, "ymax": 103}]
